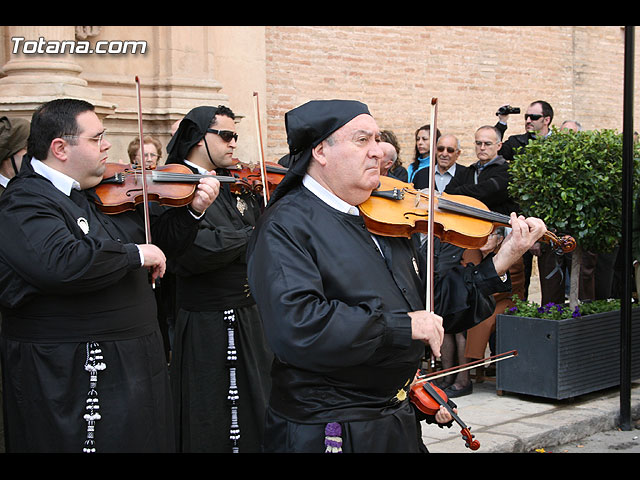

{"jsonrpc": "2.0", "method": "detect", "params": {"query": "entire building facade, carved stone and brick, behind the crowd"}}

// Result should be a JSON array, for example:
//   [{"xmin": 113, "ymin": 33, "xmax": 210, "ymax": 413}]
[{"xmin": 0, "ymin": 26, "xmax": 638, "ymax": 169}]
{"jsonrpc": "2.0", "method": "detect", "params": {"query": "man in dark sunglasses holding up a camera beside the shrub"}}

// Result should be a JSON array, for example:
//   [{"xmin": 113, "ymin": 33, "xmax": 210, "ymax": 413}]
[{"xmin": 496, "ymin": 100, "xmax": 553, "ymax": 161}]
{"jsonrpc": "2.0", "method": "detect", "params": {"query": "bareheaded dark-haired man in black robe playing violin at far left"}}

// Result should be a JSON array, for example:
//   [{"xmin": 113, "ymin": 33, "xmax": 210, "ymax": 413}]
[{"xmin": 0, "ymin": 99, "xmax": 219, "ymax": 452}]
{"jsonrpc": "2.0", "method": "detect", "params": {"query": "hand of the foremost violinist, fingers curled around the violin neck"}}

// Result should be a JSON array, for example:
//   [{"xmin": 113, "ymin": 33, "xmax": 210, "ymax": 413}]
[{"xmin": 493, "ymin": 213, "xmax": 547, "ymax": 275}]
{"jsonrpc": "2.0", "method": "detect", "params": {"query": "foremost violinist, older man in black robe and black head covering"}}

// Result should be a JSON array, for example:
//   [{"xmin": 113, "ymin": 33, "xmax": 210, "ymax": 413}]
[{"xmin": 248, "ymin": 100, "xmax": 543, "ymax": 452}]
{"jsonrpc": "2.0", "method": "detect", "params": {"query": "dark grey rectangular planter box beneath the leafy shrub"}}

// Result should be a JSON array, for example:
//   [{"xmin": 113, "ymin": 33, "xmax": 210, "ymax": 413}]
[{"xmin": 496, "ymin": 308, "xmax": 640, "ymax": 400}]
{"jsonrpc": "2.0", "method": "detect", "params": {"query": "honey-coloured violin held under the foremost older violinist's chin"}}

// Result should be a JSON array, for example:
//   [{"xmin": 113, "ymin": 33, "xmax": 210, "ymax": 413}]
[{"xmin": 358, "ymin": 176, "xmax": 576, "ymax": 253}]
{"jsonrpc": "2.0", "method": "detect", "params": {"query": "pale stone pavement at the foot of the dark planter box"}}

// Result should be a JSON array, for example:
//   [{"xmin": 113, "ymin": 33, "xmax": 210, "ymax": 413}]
[{"xmin": 422, "ymin": 376, "xmax": 640, "ymax": 453}]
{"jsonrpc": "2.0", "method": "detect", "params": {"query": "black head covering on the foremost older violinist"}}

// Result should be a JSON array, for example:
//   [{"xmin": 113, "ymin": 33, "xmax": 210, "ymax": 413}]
[{"xmin": 269, "ymin": 100, "xmax": 371, "ymax": 205}]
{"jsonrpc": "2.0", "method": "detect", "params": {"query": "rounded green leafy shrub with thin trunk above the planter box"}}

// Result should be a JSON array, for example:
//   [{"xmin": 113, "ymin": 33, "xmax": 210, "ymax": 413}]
[{"xmin": 509, "ymin": 127, "xmax": 640, "ymax": 307}]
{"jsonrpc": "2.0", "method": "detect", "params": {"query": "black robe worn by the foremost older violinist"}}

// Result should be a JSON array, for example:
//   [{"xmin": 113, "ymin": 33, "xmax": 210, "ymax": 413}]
[{"xmin": 248, "ymin": 182, "xmax": 509, "ymax": 452}]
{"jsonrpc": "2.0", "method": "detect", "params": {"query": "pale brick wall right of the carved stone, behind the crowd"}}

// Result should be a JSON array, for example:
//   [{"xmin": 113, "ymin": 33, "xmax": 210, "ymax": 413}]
[{"xmin": 265, "ymin": 26, "xmax": 638, "ymax": 169}]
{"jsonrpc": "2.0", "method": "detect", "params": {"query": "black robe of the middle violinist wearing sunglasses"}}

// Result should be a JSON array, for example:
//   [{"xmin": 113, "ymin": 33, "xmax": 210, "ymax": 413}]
[{"xmin": 171, "ymin": 171, "xmax": 273, "ymax": 453}]
